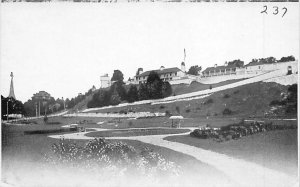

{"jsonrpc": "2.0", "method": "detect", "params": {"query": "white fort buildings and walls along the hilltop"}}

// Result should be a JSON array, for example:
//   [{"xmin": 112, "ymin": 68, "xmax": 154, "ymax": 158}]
[{"xmin": 100, "ymin": 60, "xmax": 298, "ymax": 88}]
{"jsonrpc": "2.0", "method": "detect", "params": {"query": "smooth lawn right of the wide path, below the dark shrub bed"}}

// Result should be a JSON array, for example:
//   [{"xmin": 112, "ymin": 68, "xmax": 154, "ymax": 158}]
[{"xmin": 165, "ymin": 129, "xmax": 298, "ymax": 176}]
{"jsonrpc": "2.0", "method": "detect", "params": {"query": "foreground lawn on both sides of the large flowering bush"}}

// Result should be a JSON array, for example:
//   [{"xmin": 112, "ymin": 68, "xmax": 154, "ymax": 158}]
[{"xmin": 1, "ymin": 125, "xmax": 236, "ymax": 184}]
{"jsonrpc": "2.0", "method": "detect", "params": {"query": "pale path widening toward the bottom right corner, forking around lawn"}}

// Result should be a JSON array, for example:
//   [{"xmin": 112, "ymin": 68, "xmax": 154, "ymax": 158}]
[{"xmin": 49, "ymin": 128, "xmax": 299, "ymax": 187}]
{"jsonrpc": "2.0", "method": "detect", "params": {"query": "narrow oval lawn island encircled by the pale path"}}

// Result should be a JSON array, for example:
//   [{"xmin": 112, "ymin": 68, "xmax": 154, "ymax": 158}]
[{"xmin": 86, "ymin": 128, "xmax": 190, "ymax": 137}]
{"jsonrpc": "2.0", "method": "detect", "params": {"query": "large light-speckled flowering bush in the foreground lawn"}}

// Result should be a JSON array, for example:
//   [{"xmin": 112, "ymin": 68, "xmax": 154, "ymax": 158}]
[{"xmin": 45, "ymin": 139, "xmax": 180, "ymax": 178}]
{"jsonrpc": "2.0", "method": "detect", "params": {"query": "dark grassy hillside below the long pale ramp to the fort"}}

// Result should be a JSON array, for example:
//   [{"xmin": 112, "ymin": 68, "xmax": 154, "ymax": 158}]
[{"xmin": 89, "ymin": 82, "xmax": 296, "ymax": 118}]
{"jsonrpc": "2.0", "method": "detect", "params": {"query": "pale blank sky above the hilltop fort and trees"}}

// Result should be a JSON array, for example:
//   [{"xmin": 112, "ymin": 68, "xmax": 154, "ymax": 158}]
[{"xmin": 0, "ymin": 3, "xmax": 299, "ymax": 102}]
